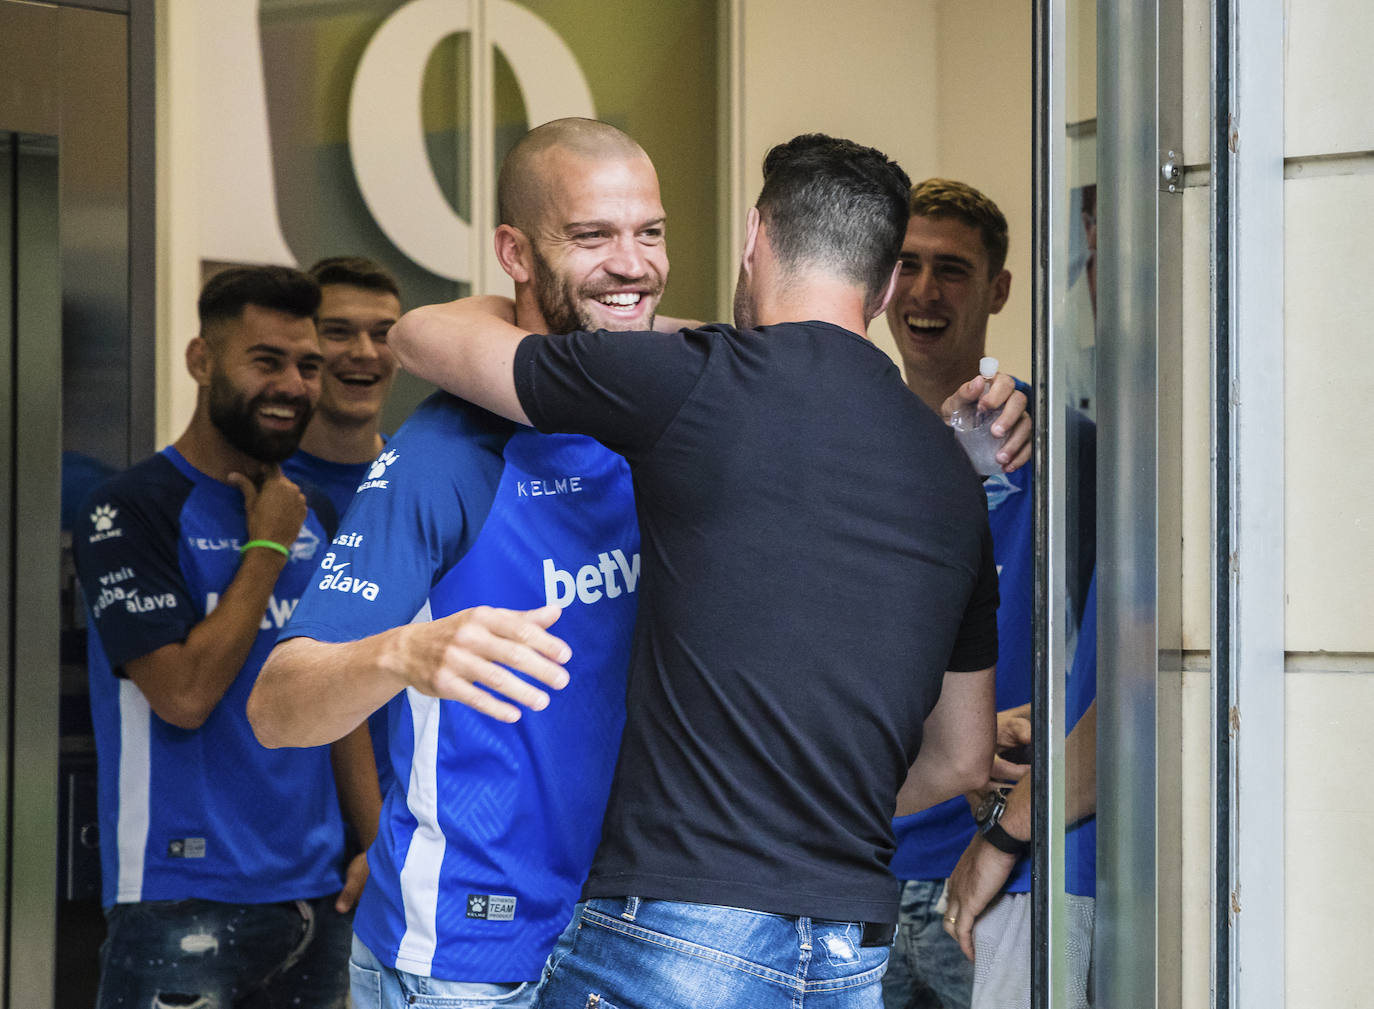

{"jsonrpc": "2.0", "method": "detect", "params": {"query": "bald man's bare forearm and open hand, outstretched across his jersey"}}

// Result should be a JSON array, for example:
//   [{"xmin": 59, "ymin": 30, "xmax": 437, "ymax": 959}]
[{"xmin": 247, "ymin": 606, "xmax": 572, "ymax": 746}]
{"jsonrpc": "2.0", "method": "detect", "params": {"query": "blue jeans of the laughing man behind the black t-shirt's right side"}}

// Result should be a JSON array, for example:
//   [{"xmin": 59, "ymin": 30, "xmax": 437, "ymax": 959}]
[{"xmin": 882, "ymin": 880, "xmax": 973, "ymax": 1009}]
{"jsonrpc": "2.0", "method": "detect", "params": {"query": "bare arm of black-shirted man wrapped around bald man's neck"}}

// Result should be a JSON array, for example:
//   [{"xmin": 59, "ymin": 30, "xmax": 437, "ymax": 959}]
[{"xmin": 386, "ymin": 296, "xmax": 529, "ymax": 425}]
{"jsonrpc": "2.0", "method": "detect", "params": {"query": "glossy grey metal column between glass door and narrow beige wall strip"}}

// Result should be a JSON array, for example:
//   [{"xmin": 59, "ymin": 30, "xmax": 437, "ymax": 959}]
[{"xmin": 1094, "ymin": 0, "xmax": 1183, "ymax": 1006}]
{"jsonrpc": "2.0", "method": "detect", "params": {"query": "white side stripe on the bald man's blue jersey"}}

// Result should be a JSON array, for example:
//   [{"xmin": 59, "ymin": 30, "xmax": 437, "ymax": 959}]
[{"xmin": 396, "ymin": 601, "xmax": 447, "ymax": 977}]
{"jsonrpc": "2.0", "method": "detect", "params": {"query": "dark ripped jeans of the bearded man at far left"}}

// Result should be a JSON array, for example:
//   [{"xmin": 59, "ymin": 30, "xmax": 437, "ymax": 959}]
[{"xmin": 96, "ymin": 896, "xmax": 353, "ymax": 1009}]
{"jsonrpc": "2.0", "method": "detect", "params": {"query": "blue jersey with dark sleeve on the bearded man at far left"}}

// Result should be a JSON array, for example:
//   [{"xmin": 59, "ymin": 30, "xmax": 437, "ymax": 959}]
[{"xmin": 73, "ymin": 448, "xmax": 344, "ymax": 906}]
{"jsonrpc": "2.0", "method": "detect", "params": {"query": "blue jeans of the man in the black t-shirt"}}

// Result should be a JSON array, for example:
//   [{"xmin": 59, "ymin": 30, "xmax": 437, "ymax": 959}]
[{"xmin": 534, "ymin": 898, "xmax": 888, "ymax": 1009}]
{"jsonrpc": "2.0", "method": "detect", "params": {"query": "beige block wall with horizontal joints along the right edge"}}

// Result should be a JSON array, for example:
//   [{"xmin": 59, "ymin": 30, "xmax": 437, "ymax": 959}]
[{"xmin": 1283, "ymin": 0, "xmax": 1374, "ymax": 1006}]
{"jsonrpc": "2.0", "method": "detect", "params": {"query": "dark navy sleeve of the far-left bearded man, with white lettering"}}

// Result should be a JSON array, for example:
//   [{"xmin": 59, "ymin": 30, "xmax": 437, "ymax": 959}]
[{"xmin": 71, "ymin": 481, "xmax": 203, "ymax": 676}]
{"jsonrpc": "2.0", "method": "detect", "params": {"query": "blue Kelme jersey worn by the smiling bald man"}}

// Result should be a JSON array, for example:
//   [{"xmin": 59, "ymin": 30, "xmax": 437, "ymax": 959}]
[{"xmin": 286, "ymin": 393, "xmax": 640, "ymax": 982}]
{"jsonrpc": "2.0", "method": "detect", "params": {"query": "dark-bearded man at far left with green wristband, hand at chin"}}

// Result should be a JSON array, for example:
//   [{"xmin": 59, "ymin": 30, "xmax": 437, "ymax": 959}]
[{"xmin": 73, "ymin": 267, "xmax": 375, "ymax": 1009}]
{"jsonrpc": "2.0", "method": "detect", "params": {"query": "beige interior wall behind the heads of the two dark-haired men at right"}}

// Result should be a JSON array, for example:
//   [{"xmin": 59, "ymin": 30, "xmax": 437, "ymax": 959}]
[{"xmin": 735, "ymin": 0, "xmax": 1031, "ymax": 378}]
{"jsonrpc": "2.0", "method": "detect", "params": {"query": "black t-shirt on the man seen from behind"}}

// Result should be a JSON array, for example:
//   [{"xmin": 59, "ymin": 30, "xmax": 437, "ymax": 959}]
[{"xmin": 515, "ymin": 322, "xmax": 998, "ymax": 921}]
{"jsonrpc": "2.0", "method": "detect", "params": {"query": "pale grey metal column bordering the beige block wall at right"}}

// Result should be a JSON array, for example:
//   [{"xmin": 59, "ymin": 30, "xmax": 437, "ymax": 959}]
[{"xmin": 1212, "ymin": 0, "xmax": 1285, "ymax": 1009}]
